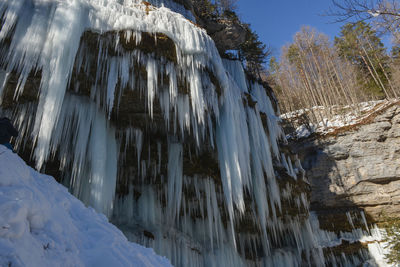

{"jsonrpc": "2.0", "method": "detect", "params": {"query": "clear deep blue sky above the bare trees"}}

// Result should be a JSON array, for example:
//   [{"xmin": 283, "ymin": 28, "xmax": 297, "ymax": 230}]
[{"xmin": 236, "ymin": 0, "xmax": 388, "ymax": 56}]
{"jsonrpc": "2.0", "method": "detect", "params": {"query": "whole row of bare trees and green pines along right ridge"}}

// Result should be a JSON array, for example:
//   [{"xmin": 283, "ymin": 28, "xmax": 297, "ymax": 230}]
[{"xmin": 267, "ymin": 0, "xmax": 400, "ymax": 129}]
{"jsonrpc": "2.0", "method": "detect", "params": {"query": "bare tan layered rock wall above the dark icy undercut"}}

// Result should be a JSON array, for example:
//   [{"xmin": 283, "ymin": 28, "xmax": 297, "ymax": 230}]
[{"xmin": 292, "ymin": 103, "xmax": 400, "ymax": 221}]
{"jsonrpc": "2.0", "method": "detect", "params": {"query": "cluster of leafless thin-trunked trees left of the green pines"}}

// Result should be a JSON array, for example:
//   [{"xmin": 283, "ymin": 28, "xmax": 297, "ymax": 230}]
[{"xmin": 271, "ymin": 27, "xmax": 368, "ymax": 129}]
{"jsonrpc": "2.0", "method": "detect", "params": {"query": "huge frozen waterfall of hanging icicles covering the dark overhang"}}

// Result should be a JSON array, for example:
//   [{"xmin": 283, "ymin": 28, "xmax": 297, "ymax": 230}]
[{"xmin": 0, "ymin": 0, "xmax": 390, "ymax": 266}]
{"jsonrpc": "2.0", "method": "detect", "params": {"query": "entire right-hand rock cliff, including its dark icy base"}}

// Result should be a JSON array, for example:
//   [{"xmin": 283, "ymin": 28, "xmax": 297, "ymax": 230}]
[{"xmin": 282, "ymin": 102, "xmax": 400, "ymax": 266}]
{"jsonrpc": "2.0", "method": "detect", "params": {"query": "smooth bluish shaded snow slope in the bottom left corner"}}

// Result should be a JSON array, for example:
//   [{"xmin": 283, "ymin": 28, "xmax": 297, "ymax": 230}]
[{"xmin": 0, "ymin": 145, "xmax": 171, "ymax": 267}]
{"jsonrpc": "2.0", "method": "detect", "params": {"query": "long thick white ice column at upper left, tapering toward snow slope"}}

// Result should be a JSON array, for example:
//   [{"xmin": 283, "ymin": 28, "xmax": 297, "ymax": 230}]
[{"xmin": 31, "ymin": 1, "xmax": 87, "ymax": 169}]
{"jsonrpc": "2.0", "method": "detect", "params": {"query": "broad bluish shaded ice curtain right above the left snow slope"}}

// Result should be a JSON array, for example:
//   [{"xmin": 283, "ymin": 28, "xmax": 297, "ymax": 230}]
[{"xmin": 47, "ymin": 94, "xmax": 120, "ymax": 217}]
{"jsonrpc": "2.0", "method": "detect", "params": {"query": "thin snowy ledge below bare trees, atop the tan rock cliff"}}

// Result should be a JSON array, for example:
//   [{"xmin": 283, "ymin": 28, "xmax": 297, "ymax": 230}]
[{"xmin": 280, "ymin": 99, "xmax": 399, "ymax": 139}]
